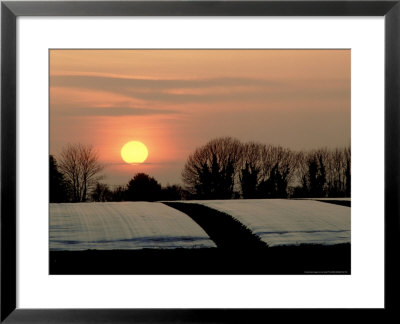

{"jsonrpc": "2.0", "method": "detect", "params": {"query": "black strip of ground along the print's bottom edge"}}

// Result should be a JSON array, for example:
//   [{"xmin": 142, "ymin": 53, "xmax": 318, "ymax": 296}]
[{"xmin": 50, "ymin": 244, "xmax": 351, "ymax": 275}]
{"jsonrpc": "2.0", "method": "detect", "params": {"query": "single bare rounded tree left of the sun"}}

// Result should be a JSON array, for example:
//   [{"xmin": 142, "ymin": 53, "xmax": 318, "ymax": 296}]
[{"xmin": 59, "ymin": 144, "xmax": 103, "ymax": 202}]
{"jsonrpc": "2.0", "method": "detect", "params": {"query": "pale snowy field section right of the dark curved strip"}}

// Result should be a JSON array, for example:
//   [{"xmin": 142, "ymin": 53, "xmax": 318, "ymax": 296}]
[{"xmin": 188, "ymin": 199, "xmax": 350, "ymax": 246}]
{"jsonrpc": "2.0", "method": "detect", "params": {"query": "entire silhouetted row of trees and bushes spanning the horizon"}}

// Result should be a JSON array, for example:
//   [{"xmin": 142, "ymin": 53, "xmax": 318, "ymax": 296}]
[{"xmin": 50, "ymin": 137, "xmax": 351, "ymax": 202}]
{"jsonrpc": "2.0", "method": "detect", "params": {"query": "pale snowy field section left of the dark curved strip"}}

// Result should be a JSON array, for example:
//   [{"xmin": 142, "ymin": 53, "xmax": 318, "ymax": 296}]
[{"xmin": 50, "ymin": 202, "xmax": 219, "ymax": 251}]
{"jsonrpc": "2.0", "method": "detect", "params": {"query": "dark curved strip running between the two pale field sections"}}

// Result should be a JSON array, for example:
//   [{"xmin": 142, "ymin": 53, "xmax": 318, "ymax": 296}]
[{"xmin": 164, "ymin": 202, "xmax": 268, "ymax": 250}]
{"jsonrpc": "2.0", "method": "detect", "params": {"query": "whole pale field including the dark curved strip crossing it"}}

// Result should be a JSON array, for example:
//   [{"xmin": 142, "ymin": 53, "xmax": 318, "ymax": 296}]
[{"xmin": 49, "ymin": 199, "xmax": 351, "ymax": 251}]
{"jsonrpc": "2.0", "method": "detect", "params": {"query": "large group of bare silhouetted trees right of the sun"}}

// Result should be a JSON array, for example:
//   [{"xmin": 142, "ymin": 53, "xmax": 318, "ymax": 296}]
[{"xmin": 182, "ymin": 137, "xmax": 351, "ymax": 199}]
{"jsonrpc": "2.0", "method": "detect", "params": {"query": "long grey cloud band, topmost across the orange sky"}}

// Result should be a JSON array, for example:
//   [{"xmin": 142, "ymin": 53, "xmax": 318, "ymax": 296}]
[{"xmin": 50, "ymin": 75, "xmax": 350, "ymax": 104}]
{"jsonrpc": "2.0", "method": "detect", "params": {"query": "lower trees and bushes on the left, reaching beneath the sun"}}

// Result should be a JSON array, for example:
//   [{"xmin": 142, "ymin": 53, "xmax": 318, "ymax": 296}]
[{"xmin": 49, "ymin": 144, "xmax": 186, "ymax": 203}]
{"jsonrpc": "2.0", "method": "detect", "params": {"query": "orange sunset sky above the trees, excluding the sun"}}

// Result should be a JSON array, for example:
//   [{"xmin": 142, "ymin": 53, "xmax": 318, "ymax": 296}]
[{"xmin": 50, "ymin": 50, "xmax": 351, "ymax": 185}]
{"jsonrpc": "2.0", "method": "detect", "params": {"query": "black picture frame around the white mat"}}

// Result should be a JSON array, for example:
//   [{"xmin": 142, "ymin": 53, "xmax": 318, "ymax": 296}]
[{"xmin": 0, "ymin": 0, "xmax": 400, "ymax": 323}]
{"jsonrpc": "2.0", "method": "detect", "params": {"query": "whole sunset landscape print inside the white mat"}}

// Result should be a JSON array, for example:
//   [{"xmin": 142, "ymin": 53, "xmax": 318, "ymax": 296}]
[{"xmin": 49, "ymin": 49, "xmax": 351, "ymax": 274}]
